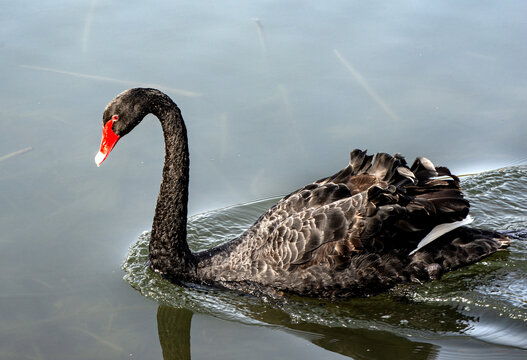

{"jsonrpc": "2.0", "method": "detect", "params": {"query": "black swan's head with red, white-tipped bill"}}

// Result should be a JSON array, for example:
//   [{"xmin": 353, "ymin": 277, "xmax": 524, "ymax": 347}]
[{"xmin": 95, "ymin": 88, "xmax": 161, "ymax": 166}]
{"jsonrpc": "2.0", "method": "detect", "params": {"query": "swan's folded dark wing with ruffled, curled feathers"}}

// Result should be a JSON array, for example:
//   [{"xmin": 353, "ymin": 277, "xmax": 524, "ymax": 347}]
[{"xmin": 256, "ymin": 150, "xmax": 469, "ymax": 270}]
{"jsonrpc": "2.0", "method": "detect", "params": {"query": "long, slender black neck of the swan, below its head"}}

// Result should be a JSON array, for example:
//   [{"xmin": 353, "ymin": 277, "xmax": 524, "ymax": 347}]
[{"xmin": 150, "ymin": 94, "xmax": 196, "ymax": 280}]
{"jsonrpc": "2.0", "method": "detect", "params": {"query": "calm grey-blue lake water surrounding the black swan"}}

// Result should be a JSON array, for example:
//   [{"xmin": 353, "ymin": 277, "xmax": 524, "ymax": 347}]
[{"xmin": 0, "ymin": 0, "xmax": 527, "ymax": 359}]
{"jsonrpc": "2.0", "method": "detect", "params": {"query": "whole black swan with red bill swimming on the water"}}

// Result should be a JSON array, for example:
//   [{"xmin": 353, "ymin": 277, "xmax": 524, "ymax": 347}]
[{"xmin": 95, "ymin": 88, "xmax": 509, "ymax": 298}]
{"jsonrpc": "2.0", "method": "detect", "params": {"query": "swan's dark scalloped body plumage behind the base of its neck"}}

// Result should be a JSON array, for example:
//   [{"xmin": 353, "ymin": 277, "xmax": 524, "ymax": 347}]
[{"xmin": 199, "ymin": 150, "xmax": 505, "ymax": 297}]
